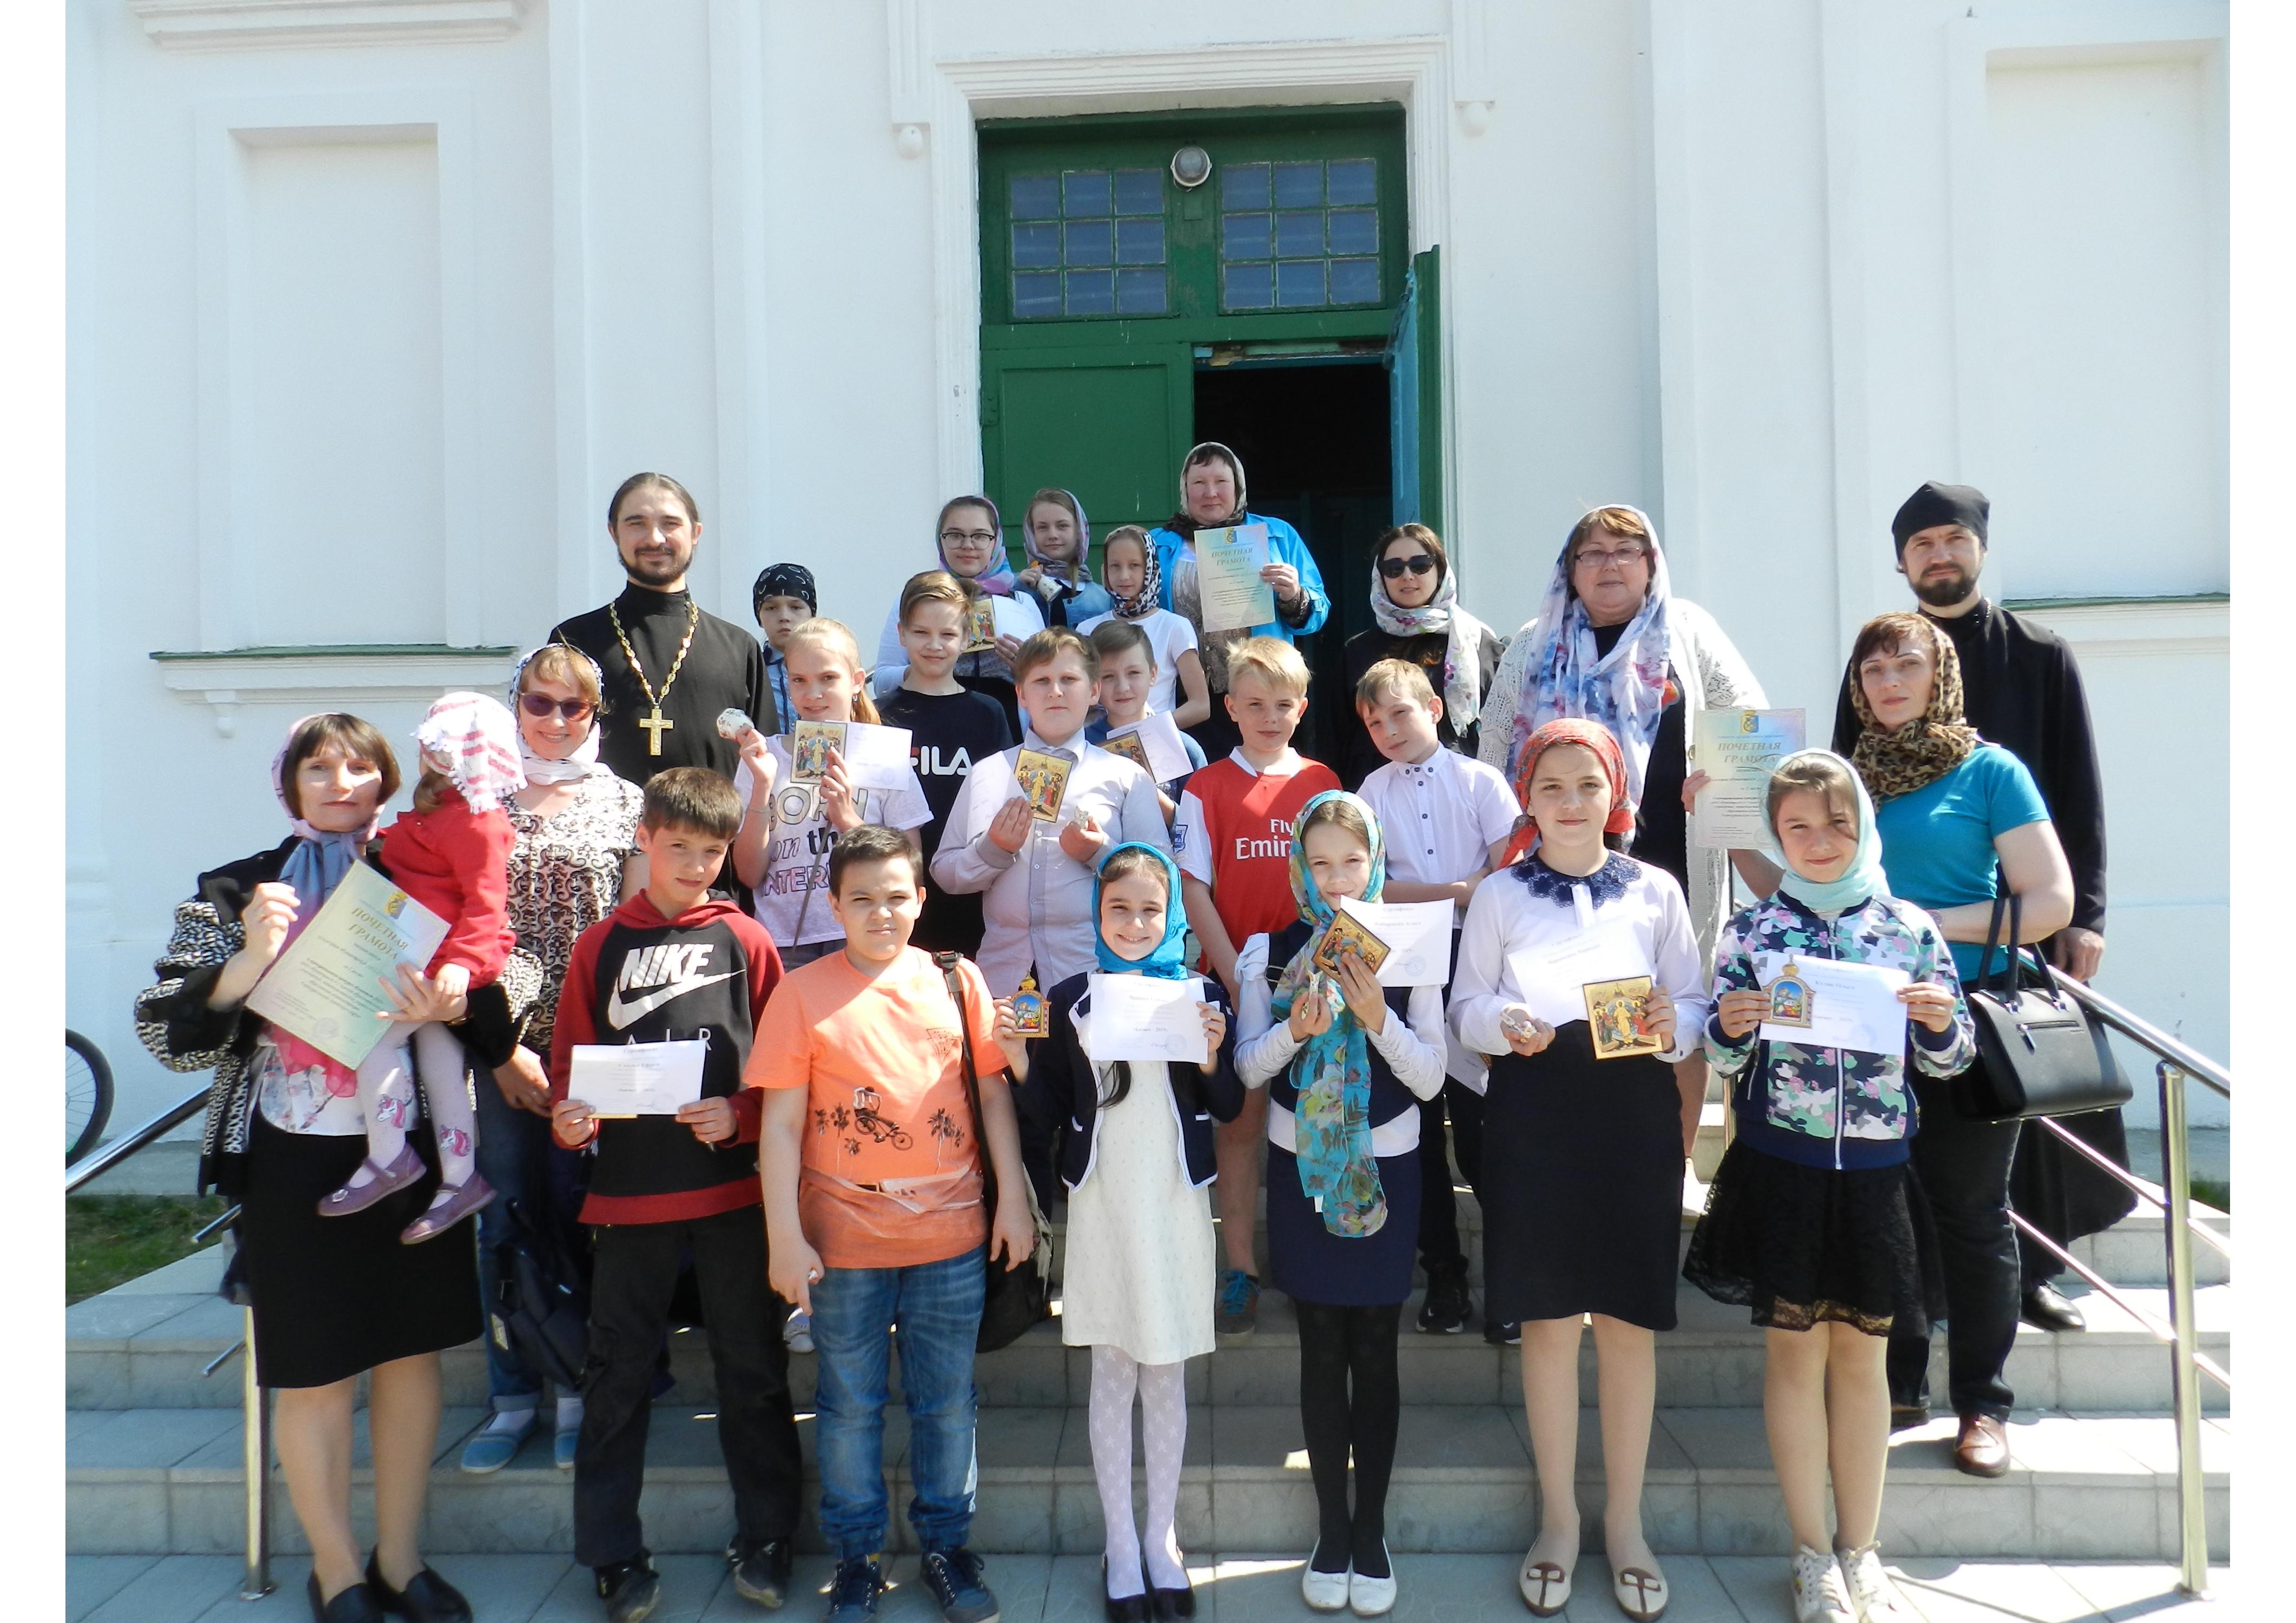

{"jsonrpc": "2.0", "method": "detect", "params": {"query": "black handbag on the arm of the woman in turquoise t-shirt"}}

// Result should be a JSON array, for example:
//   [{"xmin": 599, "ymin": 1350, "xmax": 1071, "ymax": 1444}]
[{"xmin": 1954, "ymin": 893, "xmax": 2135, "ymax": 1120}]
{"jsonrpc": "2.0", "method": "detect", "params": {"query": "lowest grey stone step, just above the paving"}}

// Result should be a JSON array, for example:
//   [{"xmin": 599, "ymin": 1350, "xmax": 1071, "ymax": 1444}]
[{"xmin": 64, "ymin": 1403, "xmax": 2229, "ymax": 1561}]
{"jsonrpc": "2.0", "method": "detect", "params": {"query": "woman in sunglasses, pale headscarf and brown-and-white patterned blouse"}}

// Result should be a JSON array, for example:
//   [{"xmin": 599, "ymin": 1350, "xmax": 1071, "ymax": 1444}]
[{"xmin": 461, "ymin": 643, "xmax": 645, "ymax": 1474}]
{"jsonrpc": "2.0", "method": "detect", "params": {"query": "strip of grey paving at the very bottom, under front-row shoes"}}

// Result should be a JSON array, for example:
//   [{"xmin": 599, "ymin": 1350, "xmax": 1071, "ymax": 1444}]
[{"xmin": 64, "ymin": 1547, "xmax": 2229, "ymax": 1623}]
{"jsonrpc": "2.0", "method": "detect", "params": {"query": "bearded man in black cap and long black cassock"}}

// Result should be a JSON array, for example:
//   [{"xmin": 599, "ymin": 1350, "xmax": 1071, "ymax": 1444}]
[{"xmin": 1835, "ymin": 482, "xmax": 2135, "ymax": 1329}]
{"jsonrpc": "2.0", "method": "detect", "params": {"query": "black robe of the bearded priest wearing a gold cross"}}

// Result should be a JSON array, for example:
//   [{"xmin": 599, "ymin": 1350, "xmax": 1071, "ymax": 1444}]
[{"xmin": 551, "ymin": 585, "xmax": 778, "ymax": 785}]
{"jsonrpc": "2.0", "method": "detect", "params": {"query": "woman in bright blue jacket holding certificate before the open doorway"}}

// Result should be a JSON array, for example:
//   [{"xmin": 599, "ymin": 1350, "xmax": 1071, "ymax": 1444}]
[{"xmin": 1148, "ymin": 439, "xmax": 1332, "ymax": 760}]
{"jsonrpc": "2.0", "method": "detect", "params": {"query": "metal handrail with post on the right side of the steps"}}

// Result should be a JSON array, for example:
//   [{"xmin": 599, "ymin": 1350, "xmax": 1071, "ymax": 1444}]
[{"xmin": 2009, "ymin": 966, "xmax": 2232, "ymax": 1595}]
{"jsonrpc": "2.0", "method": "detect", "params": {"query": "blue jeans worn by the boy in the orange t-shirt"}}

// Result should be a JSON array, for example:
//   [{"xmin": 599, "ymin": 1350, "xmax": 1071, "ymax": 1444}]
[{"xmin": 813, "ymin": 1247, "xmax": 983, "ymax": 1561}]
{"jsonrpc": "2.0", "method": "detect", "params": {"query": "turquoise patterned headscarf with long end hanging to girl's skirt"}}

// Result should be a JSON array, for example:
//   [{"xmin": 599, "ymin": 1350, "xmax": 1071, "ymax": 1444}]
[{"xmin": 1272, "ymin": 790, "xmax": 1387, "ymax": 1240}]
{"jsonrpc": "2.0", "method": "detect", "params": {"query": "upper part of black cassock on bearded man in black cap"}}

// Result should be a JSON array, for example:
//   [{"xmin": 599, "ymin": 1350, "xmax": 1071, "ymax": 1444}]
[{"xmin": 1835, "ymin": 599, "xmax": 2106, "ymax": 932}]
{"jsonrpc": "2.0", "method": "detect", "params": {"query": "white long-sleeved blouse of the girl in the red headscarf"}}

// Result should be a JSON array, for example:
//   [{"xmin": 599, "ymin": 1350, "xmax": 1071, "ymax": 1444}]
[{"xmin": 1451, "ymin": 854, "xmax": 1713, "ymax": 1063}]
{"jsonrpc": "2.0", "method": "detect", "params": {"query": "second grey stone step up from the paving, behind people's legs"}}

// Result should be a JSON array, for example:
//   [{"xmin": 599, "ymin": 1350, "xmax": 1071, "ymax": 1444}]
[{"xmin": 64, "ymin": 1251, "xmax": 2232, "ymax": 1414}]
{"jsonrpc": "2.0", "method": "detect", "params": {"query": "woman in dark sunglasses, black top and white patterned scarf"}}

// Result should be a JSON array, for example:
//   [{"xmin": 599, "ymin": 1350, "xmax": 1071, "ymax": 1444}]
[{"xmin": 1339, "ymin": 524, "xmax": 1506, "ymax": 790}]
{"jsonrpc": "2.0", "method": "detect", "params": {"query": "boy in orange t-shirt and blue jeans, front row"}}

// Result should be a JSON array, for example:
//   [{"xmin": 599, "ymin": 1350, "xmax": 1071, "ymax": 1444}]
[{"xmin": 744, "ymin": 824, "xmax": 1035, "ymax": 1623}]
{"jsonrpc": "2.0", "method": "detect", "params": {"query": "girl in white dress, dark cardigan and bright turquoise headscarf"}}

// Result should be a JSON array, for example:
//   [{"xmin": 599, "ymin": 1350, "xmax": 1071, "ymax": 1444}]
[{"xmin": 996, "ymin": 843, "xmax": 1245, "ymax": 1623}]
